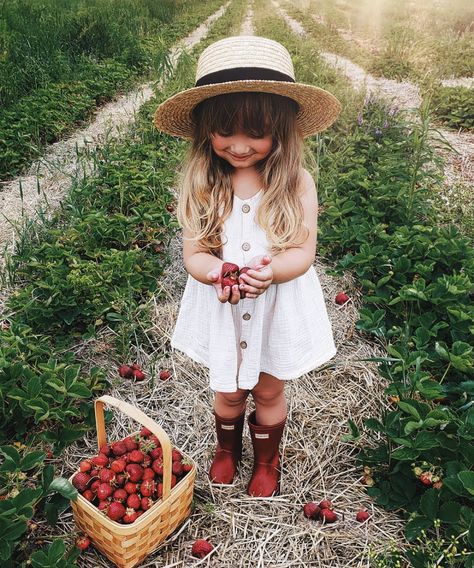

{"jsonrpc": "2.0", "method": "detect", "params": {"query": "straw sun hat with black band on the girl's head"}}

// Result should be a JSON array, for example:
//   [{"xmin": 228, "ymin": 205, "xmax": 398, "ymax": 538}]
[{"xmin": 153, "ymin": 36, "xmax": 341, "ymax": 140}]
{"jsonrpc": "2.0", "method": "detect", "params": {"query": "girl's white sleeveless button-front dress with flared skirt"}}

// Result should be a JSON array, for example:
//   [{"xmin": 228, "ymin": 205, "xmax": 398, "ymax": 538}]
[{"xmin": 171, "ymin": 190, "xmax": 336, "ymax": 392}]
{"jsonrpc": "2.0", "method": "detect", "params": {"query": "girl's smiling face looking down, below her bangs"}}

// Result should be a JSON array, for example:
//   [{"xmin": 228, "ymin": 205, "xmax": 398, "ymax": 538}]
[{"xmin": 211, "ymin": 129, "xmax": 273, "ymax": 169}]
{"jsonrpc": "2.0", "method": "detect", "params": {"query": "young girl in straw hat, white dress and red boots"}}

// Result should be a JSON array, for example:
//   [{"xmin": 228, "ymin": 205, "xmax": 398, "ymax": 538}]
[{"xmin": 154, "ymin": 36, "xmax": 341, "ymax": 497}]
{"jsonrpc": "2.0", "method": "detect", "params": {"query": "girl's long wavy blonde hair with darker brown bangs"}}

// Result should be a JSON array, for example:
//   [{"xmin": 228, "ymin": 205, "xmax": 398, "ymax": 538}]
[{"xmin": 176, "ymin": 92, "xmax": 308, "ymax": 260}]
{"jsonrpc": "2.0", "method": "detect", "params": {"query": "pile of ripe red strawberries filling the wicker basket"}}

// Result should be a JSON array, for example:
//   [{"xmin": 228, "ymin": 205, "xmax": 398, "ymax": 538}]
[{"xmin": 72, "ymin": 428, "xmax": 193, "ymax": 524}]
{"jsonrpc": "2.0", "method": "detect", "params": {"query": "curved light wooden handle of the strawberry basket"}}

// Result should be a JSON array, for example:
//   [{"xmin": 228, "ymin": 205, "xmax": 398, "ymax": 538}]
[{"xmin": 94, "ymin": 395, "xmax": 172, "ymax": 501}]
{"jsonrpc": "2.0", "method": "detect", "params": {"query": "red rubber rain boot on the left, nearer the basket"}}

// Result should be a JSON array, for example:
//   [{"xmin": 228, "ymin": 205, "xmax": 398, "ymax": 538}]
[{"xmin": 209, "ymin": 410, "xmax": 245, "ymax": 485}]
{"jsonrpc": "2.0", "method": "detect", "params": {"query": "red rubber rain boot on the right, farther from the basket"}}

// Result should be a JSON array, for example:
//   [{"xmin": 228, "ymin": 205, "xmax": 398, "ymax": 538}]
[{"xmin": 247, "ymin": 410, "xmax": 286, "ymax": 497}]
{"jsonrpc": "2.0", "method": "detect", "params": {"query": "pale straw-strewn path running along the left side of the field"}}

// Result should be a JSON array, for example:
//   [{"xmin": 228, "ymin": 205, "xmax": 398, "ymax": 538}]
[{"xmin": 0, "ymin": 1, "xmax": 230, "ymax": 269}]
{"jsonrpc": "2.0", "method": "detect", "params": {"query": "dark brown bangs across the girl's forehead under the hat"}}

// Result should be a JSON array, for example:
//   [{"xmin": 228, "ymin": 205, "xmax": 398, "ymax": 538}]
[{"xmin": 193, "ymin": 91, "xmax": 299, "ymax": 138}]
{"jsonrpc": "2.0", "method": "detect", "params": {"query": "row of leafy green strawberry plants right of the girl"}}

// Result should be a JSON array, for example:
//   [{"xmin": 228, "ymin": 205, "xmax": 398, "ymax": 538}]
[{"xmin": 318, "ymin": 97, "xmax": 474, "ymax": 567}]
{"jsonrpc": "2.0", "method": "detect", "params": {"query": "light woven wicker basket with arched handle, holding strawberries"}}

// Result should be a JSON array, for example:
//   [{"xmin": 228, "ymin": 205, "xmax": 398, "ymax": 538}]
[{"xmin": 69, "ymin": 396, "xmax": 196, "ymax": 568}]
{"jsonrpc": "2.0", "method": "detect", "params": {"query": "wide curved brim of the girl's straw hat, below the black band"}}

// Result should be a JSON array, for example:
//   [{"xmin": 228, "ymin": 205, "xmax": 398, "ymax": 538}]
[{"xmin": 153, "ymin": 79, "xmax": 342, "ymax": 140}]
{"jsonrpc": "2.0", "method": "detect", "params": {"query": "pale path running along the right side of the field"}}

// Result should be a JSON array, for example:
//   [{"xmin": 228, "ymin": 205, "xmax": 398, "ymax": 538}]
[{"xmin": 272, "ymin": 0, "xmax": 474, "ymax": 193}]
